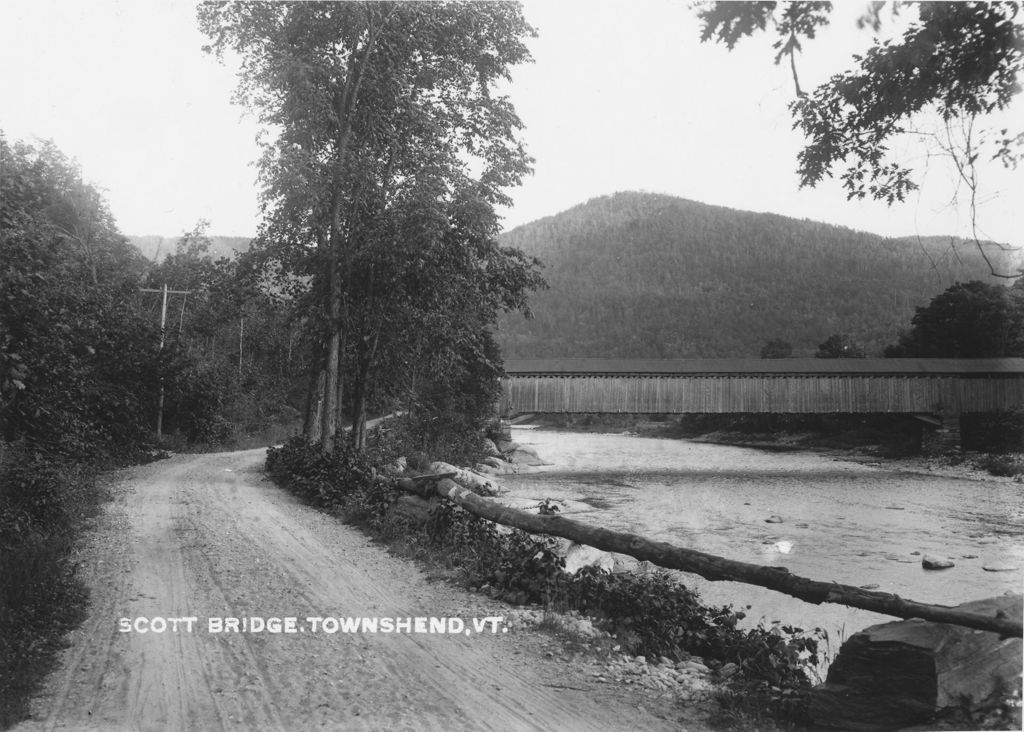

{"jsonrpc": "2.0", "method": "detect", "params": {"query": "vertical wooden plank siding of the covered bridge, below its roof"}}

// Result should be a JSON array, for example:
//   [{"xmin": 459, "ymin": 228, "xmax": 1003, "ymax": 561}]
[{"xmin": 503, "ymin": 375, "xmax": 1024, "ymax": 414}]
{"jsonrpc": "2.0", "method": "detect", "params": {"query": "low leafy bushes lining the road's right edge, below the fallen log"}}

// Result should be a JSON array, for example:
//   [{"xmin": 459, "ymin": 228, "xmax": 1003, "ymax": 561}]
[{"xmin": 267, "ymin": 438, "xmax": 820, "ymax": 688}]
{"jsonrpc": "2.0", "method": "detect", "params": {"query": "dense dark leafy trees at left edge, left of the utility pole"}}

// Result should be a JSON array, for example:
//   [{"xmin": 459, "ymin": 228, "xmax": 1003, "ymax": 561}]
[{"xmin": 0, "ymin": 136, "xmax": 163, "ymax": 459}]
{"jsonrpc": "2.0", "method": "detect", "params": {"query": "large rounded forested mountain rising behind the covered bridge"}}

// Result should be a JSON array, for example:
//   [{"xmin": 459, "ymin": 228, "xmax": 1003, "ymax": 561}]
[{"xmin": 500, "ymin": 192, "xmax": 1020, "ymax": 358}]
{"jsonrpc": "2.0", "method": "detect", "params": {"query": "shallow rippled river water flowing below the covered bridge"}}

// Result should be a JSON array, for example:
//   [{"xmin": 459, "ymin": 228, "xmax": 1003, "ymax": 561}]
[{"xmin": 502, "ymin": 428, "xmax": 1024, "ymax": 639}]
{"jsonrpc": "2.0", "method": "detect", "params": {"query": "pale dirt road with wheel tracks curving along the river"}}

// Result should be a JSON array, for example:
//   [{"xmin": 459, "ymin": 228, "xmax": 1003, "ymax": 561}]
[{"xmin": 17, "ymin": 449, "xmax": 696, "ymax": 730}]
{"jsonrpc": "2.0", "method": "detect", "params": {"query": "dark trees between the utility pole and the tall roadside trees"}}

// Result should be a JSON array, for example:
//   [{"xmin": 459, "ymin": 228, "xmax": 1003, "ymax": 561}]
[{"xmin": 143, "ymin": 221, "xmax": 309, "ymax": 444}]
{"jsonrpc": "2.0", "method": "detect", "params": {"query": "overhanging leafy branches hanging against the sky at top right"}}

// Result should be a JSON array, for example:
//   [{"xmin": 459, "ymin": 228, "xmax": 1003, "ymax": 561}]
[{"xmin": 698, "ymin": 2, "xmax": 1024, "ymax": 277}]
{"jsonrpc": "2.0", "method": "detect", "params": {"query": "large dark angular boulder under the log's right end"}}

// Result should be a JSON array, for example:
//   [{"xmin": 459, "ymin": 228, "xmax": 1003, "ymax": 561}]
[{"xmin": 810, "ymin": 595, "xmax": 1024, "ymax": 730}]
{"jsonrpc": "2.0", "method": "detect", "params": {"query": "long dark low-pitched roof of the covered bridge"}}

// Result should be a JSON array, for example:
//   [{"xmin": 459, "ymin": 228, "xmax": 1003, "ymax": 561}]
[{"xmin": 505, "ymin": 358, "xmax": 1024, "ymax": 376}]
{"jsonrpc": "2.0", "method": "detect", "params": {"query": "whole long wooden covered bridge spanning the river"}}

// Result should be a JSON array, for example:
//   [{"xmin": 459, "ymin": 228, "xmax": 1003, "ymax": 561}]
[{"xmin": 500, "ymin": 358, "xmax": 1024, "ymax": 450}]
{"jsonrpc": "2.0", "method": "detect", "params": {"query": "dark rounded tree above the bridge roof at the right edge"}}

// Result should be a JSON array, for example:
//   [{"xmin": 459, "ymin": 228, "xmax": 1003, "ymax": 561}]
[{"xmin": 886, "ymin": 279, "xmax": 1024, "ymax": 358}]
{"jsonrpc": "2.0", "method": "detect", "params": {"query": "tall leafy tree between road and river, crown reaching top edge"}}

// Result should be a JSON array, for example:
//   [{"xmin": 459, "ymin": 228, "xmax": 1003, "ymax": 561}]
[{"xmin": 199, "ymin": 2, "xmax": 532, "ymax": 449}]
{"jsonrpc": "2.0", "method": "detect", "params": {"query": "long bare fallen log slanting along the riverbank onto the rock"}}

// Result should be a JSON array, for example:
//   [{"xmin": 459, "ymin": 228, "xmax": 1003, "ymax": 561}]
[{"xmin": 436, "ymin": 478, "xmax": 1024, "ymax": 638}]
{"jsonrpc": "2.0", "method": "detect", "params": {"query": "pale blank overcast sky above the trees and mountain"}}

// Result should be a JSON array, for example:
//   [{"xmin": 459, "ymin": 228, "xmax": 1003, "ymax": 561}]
[{"xmin": 0, "ymin": 0, "xmax": 1024, "ymax": 245}]
